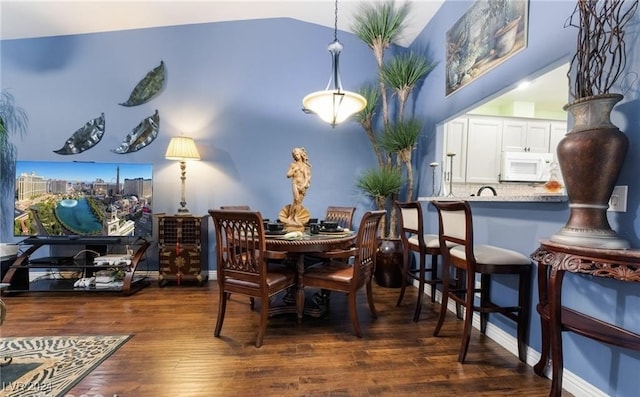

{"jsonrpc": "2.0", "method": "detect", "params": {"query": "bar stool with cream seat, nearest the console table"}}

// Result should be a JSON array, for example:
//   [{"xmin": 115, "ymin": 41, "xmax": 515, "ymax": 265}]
[{"xmin": 432, "ymin": 201, "xmax": 531, "ymax": 363}]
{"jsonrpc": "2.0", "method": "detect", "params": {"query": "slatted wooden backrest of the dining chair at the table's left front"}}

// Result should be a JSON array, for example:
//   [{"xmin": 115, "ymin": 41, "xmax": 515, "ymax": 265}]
[{"xmin": 209, "ymin": 210, "xmax": 267, "ymax": 286}]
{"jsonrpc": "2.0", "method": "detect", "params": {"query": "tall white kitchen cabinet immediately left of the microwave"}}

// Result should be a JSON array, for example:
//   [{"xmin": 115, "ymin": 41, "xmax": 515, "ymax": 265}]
[{"xmin": 466, "ymin": 117, "xmax": 502, "ymax": 184}]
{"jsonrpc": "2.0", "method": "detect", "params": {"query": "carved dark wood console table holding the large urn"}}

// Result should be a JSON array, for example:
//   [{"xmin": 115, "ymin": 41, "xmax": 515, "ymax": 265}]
[{"xmin": 531, "ymin": 240, "xmax": 640, "ymax": 396}]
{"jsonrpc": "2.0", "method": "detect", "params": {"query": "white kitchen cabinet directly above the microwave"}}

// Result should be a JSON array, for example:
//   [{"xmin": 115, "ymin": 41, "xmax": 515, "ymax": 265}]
[{"xmin": 502, "ymin": 119, "xmax": 551, "ymax": 153}]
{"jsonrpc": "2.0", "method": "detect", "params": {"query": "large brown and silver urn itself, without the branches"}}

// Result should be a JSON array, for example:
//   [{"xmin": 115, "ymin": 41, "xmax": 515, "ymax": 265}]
[{"xmin": 551, "ymin": 94, "xmax": 629, "ymax": 249}]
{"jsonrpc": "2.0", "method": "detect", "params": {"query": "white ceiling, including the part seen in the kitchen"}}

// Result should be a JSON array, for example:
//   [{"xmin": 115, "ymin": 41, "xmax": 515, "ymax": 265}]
[{"xmin": 0, "ymin": 0, "xmax": 567, "ymax": 108}]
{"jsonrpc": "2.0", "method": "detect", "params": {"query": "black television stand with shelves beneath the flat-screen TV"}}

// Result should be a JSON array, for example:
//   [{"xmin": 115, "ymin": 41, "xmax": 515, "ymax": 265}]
[{"xmin": 2, "ymin": 236, "xmax": 150, "ymax": 295}]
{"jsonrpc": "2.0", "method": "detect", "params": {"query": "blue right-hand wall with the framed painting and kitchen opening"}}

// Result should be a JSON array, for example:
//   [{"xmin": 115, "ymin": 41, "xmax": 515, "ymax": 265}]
[{"xmin": 412, "ymin": 0, "xmax": 640, "ymax": 396}]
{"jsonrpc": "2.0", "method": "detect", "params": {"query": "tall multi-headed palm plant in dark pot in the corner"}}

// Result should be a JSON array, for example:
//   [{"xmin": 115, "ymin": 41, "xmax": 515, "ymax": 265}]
[{"xmin": 352, "ymin": 0, "xmax": 434, "ymax": 287}]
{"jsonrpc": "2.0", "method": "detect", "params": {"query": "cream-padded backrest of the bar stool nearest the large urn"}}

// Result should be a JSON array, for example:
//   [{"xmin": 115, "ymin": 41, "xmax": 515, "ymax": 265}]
[{"xmin": 431, "ymin": 201, "xmax": 475, "ymax": 267}]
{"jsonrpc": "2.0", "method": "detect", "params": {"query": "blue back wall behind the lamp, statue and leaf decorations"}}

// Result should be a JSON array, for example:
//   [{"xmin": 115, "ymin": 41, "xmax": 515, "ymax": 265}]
[{"xmin": 0, "ymin": 18, "xmax": 376, "ymax": 246}]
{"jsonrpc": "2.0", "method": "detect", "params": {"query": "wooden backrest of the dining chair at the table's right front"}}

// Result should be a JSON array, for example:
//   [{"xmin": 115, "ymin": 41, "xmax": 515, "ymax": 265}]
[{"xmin": 351, "ymin": 210, "xmax": 387, "ymax": 290}]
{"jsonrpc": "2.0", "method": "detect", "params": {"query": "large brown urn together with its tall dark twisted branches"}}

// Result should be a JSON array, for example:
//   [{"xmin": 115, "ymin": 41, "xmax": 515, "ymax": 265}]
[{"xmin": 551, "ymin": 0, "xmax": 638, "ymax": 249}]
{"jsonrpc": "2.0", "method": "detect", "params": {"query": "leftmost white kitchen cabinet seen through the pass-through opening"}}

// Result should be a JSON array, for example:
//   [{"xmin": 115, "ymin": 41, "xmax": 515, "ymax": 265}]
[{"xmin": 442, "ymin": 117, "xmax": 468, "ymax": 183}]
